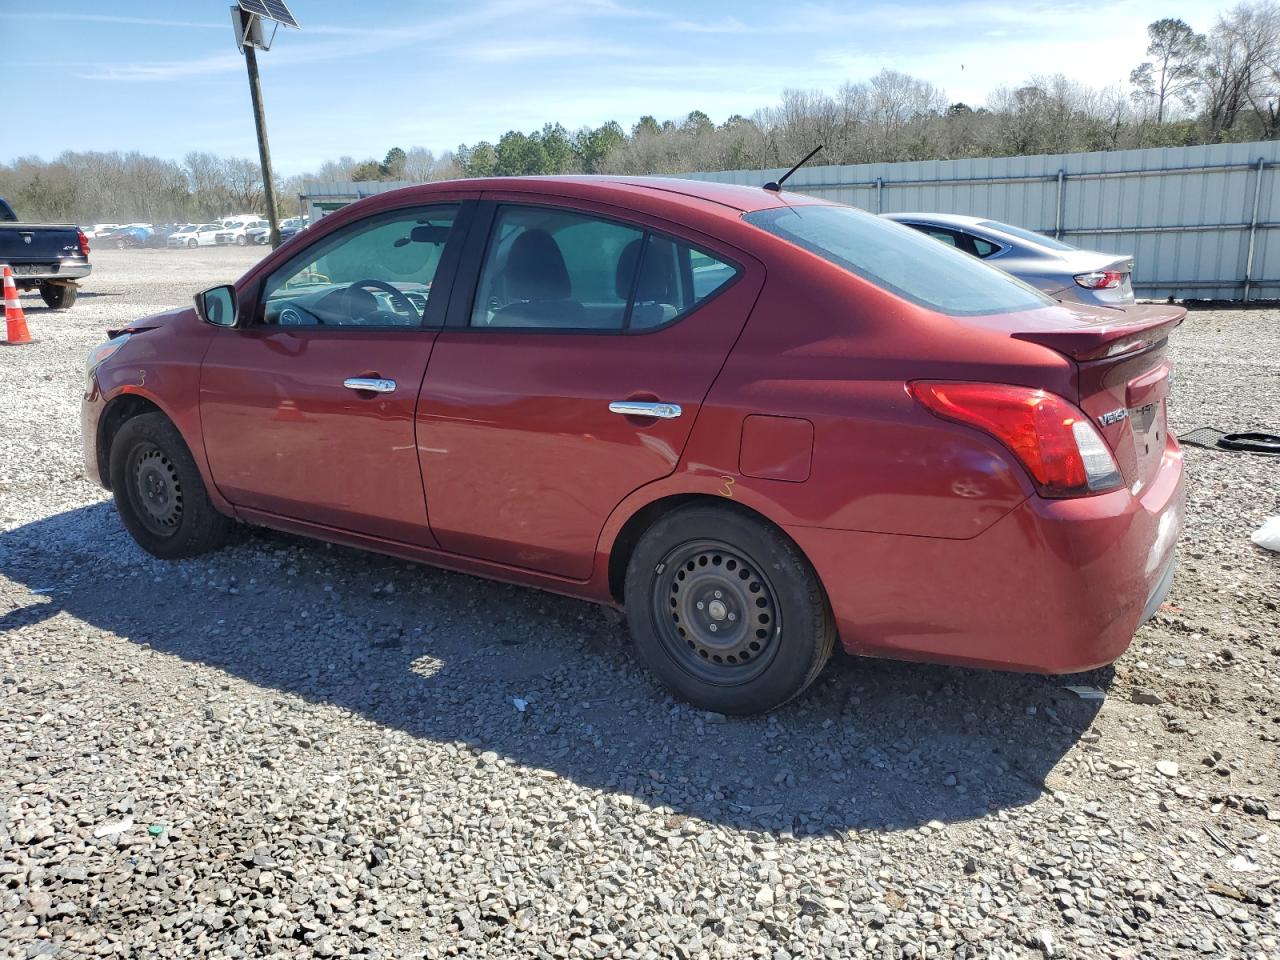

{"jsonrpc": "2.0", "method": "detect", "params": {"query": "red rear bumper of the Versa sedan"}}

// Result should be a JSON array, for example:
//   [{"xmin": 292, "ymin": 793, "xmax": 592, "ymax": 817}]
[{"xmin": 787, "ymin": 442, "xmax": 1183, "ymax": 673}]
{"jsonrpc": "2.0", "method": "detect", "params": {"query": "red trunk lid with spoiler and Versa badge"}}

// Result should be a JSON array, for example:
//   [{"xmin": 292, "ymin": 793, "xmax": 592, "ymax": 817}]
[{"xmin": 1010, "ymin": 305, "xmax": 1187, "ymax": 494}]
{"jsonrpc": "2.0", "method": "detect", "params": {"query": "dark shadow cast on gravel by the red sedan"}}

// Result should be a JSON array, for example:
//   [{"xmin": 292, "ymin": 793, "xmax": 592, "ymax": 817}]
[{"xmin": 0, "ymin": 503, "xmax": 1111, "ymax": 833}]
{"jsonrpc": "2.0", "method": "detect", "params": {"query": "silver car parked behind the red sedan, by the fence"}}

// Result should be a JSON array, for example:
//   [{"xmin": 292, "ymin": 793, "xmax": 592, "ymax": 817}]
[{"xmin": 883, "ymin": 214, "xmax": 1133, "ymax": 306}]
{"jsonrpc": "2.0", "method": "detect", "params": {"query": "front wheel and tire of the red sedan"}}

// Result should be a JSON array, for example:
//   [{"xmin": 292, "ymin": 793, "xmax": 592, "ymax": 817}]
[{"xmin": 110, "ymin": 413, "xmax": 230, "ymax": 559}]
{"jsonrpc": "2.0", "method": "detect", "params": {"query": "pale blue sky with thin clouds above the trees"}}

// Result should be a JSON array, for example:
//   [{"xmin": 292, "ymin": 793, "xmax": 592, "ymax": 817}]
[{"xmin": 0, "ymin": 0, "xmax": 1225, "ymax": 175}]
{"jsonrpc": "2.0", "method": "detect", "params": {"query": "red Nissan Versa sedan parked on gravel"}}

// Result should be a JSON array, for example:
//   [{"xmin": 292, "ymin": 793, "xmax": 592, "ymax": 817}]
[{"xmin": 83, "ymin": 178, "xmax": 1184, "ymax": 713}]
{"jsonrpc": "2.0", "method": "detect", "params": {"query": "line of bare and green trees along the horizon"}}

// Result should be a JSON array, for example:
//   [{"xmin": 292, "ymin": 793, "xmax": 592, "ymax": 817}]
[{"xmin": 0, "ymin": 0, "xmax": 1280, "ymax": 223}]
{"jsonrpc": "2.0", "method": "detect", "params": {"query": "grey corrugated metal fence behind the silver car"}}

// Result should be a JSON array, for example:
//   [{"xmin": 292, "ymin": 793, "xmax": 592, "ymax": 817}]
[{"xmin": 685, "ymin": 141, "xmax": 1280, "ymax": 300}]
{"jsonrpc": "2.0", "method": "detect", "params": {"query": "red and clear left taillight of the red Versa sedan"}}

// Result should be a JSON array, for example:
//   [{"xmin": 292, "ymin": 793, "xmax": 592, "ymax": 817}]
[{"xmin": 908, "ymin": 380, "xmax": 1123, "ymax": 497}]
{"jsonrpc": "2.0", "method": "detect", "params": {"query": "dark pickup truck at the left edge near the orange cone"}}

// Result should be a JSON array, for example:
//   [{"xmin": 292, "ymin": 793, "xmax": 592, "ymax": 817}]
[{"xmin": 0, "ymin": 197, "xmax": 92, "ymax": 310}]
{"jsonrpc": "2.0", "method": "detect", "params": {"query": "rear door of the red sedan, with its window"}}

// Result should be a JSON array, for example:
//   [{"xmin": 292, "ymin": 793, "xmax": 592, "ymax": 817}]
[{"xmin": 417, "ymin": 193, "xmax": 764, "ymax": 580}]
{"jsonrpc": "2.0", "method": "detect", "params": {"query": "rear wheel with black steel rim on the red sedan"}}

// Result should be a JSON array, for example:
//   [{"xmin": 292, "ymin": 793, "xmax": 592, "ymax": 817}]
[{"xmin": 626, "ymin": 506, "xmax": 836, "ymax": 714}]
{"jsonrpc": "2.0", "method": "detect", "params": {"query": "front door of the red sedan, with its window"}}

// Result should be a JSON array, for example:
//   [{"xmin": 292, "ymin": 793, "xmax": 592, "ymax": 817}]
[{"xmin": 200, "ymin": 201, "xmax": 468, "ymax": 545}]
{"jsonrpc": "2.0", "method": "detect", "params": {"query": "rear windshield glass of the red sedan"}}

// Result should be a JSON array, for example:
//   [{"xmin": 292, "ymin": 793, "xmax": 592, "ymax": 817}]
[{"xmin": 742, "ymin": 205, "xmax": 1053, "ymax": 316}]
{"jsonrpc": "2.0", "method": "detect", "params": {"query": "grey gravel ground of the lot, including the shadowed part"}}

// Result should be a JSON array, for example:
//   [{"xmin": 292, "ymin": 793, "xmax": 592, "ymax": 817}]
[{"xmin": 0, "ymin": 250, "xmax": 1280, "ymax": 960}]
